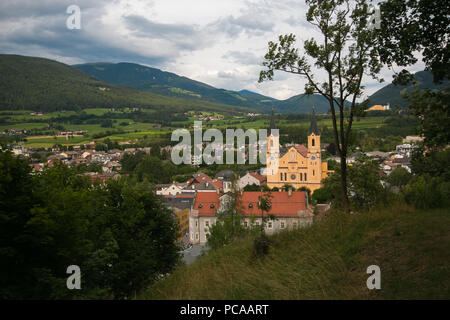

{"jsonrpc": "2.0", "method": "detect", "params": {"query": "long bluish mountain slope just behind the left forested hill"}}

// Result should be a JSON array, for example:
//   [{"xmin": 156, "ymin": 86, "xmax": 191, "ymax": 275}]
[{"xmin": 74, "ymin": 62, "xmax": 276, "ymax": 111}]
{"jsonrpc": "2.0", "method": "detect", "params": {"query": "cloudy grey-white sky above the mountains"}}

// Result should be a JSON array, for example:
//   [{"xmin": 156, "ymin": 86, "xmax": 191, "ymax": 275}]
[{"xmin": 0, "ymin": 0, "xmax": 423, "ymax": 99}]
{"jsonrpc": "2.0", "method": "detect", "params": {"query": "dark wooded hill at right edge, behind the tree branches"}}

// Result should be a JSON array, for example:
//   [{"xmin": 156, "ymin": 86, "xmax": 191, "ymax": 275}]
[{"xmin": 369, "ymin": 71, "xmax": 450, "ymax": 108}]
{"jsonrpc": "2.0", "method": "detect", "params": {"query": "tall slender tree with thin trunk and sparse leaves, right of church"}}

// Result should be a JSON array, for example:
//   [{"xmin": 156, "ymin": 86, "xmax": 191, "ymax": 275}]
[{"xmin": 259, "ymin": 0, "xmax": 381, "ymax": 211}]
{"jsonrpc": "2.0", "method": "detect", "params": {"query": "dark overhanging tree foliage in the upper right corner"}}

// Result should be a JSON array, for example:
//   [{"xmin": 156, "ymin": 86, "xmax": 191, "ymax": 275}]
[{"xmin": 378, "ymin": 0, "xmax": 450, "ymax": 84}]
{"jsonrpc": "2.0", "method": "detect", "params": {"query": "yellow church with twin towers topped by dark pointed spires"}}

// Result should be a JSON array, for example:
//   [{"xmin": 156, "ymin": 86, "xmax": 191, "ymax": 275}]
[{"xmin": 266, "ymin": 109, "xmax": 329, "ymax": 191}]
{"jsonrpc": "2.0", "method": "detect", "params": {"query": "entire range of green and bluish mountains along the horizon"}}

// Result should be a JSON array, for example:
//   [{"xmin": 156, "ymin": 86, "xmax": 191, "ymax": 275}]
[{"xmin": 0, "ymin": 55, "xmax": 449, "ymax": 113}]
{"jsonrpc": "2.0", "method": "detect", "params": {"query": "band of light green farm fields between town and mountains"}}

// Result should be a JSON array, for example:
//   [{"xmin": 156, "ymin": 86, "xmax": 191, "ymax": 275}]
[{"xmin": 0, "ymin": 108, "xmax": 385, "ymax": 148}]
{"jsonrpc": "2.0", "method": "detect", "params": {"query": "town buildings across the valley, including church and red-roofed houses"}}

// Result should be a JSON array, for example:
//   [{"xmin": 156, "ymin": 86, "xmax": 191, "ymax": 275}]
[{"xmin": 3, "ymin": 119, "xmax": 421, "ymax": 247}]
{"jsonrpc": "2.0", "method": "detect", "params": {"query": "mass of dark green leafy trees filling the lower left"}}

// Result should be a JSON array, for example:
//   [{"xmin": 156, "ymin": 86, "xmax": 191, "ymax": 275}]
[{"xmin": 0, "ymin": 152, "xmax": 179, "ymax": 299}]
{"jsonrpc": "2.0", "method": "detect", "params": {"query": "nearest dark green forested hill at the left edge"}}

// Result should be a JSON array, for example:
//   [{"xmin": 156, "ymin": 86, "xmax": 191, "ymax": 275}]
[{"xmin": 0, "ymin": 55, "xmax": 249, "ymax": 112}]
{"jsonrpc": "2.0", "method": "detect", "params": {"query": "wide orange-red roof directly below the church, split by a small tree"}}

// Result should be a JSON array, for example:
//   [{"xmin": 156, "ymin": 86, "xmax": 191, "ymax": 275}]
[{"xmin": 239, "ymin": 191, "xmax": 306, "ymax": 217}]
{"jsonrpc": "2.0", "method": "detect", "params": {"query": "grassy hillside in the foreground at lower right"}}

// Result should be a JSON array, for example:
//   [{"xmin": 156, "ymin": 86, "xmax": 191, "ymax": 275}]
[{"xmin": 143, "ymin": 206, "xmax": 450, "ymax": 299}]
